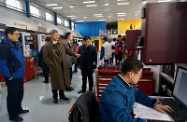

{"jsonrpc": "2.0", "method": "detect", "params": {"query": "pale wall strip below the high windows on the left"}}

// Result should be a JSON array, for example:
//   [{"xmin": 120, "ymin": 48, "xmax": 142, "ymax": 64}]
[{"xmin": 0, "ymin": 6, "xmax": 80, "ymax": 36}]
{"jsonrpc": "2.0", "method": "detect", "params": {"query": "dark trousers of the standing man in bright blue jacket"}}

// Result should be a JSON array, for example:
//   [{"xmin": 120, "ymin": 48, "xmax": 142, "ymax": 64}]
[{"xmin": 5, "ymin": 78, "xmax": 24, "ymax": 119}]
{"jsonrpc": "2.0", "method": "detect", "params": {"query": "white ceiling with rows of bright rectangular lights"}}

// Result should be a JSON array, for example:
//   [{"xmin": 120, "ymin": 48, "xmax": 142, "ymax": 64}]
[{"xmin": 30, "ymin": 0, "xmax": 176, "ymax": 22}]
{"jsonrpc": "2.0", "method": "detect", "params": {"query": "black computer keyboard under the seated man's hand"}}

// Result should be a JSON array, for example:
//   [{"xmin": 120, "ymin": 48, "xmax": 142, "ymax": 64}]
[{"xmin": 159, "ymin": 98, "xmax": 187, "ymax": 122}]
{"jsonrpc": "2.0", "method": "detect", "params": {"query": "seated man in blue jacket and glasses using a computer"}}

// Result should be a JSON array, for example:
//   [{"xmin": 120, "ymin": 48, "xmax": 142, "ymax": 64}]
[{"xmin": 99, "ymin": 58, "xmax": 173, "ymax": 122}]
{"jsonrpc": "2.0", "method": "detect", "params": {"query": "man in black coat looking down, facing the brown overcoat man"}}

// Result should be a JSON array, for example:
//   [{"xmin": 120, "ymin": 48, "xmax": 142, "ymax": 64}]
[{"xmin": 78, "ymin": 36, "xmax": 97, "ymax": 93}]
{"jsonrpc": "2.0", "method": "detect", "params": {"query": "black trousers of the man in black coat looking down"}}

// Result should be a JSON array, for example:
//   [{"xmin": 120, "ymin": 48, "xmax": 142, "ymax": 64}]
[{"xmin": 81, "ymin": 68, "xmax": 93, "ymax": 91}]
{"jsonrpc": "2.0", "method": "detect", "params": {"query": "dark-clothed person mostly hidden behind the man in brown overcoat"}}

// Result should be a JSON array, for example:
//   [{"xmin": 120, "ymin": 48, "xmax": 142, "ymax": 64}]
[{"xmin": 38, "ymin": 37, "xmax": 51, "ymax": 83}]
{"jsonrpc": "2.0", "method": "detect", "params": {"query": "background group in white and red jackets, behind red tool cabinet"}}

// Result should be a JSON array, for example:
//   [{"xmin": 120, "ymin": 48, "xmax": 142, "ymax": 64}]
[{"xmin": 100, "ymin": 35, "xmax": 127, "ymax": 64}]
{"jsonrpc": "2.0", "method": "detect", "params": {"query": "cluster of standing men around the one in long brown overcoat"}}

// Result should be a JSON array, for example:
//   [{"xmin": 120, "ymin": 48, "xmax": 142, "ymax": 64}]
[{"xmin": 39, "ymin": 30, "xmax": 97, "ymax": 103}]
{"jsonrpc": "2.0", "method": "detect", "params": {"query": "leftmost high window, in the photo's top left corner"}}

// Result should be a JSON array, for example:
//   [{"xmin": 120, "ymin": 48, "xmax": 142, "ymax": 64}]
[{"xmin": 5, "ymin": 0, "xmax": 23, "ymax": 11}]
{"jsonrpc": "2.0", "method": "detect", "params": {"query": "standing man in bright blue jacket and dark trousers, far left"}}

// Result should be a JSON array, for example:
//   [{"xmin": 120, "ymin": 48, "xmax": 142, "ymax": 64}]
[{"xmin": 0, "ymin": 27, "xmax": 29, "ymax": 122}]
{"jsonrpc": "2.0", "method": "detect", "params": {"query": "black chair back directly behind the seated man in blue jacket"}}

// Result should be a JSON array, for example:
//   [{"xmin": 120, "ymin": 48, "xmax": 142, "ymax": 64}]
[{"xmin": 69, "ymin": 91, "xmax": 99, "ymax": 122}]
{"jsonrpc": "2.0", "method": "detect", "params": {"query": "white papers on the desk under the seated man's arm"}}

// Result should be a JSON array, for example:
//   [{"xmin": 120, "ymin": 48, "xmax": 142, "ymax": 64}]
[{"xmin": 134, "ymin": 103, "xmax": 172, "ymax": 121}]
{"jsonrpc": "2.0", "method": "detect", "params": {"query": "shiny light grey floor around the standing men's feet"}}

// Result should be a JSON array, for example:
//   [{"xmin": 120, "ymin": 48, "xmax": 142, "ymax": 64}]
[{"xmin": 0, "ymin": 70, "xmax": 95, "ymax": 122}]
